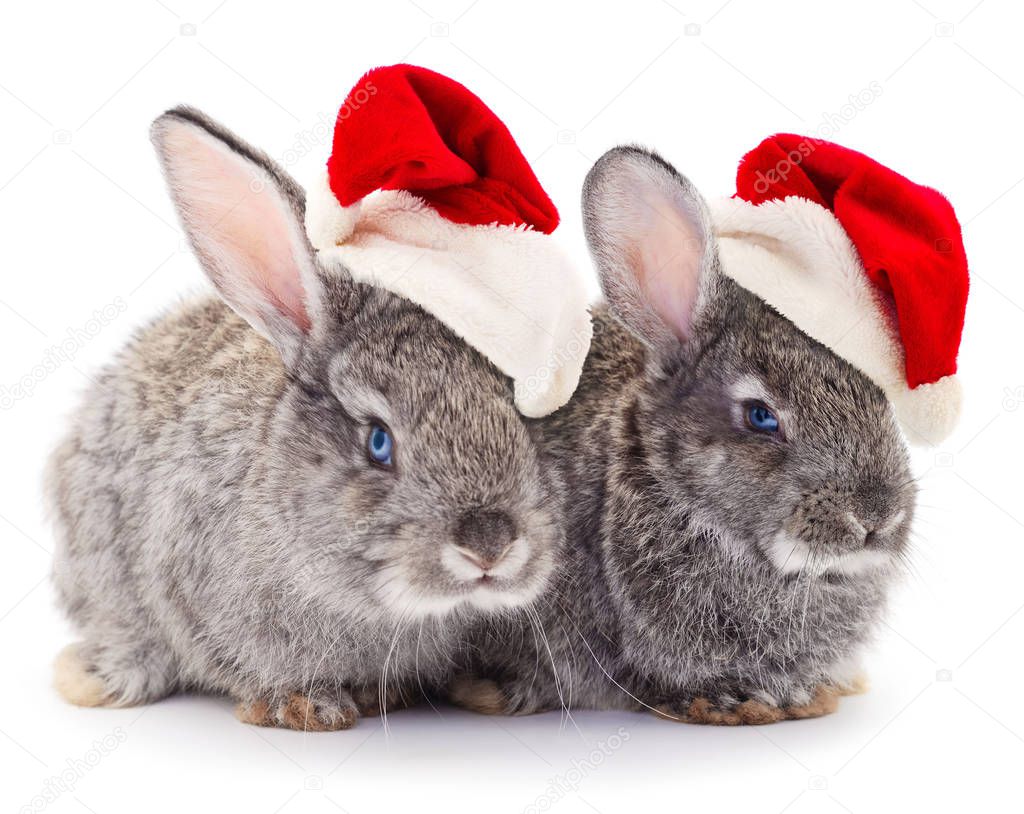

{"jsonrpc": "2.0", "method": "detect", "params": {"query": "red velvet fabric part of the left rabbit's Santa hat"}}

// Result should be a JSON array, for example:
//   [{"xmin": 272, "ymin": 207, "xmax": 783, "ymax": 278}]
[{"xmin": 327, "ymin": 65, "xmax": 558, "ymax": 233}]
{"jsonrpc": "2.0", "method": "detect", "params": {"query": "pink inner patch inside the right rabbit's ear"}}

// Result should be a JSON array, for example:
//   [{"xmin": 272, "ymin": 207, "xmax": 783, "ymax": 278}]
[{"xmin": 633, "ymin": 192, "xmax": 705, "ymax": 340}]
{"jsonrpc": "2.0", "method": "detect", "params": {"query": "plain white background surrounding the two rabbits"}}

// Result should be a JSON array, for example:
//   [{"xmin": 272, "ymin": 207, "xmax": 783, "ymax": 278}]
[{"xmin": 0, "ymin": 0, "xmax": 1024, "ymax": 814}]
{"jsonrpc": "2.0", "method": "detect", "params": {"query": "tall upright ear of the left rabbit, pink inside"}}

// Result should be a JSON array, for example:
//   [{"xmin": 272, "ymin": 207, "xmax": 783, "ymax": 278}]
[{"xmin": 152, "ymin": 108, "xmax": 321, "ymax": 363}]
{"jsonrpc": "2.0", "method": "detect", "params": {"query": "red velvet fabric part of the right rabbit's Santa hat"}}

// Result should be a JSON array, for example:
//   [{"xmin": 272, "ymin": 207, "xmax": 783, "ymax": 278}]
[{"xmin": 736, "ymin": 133, "xmax": 968, "ymax": 388}]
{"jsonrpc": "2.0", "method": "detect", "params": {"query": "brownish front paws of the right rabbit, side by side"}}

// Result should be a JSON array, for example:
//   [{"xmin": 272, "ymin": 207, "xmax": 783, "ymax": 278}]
[{"xmin": 654, "ymin": 686, "xmax": 840, "ymax": 726}]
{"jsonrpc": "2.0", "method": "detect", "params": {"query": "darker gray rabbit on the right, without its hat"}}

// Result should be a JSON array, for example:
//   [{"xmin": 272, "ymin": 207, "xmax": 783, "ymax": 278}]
[{"xmin": 451, "ymin": 147, "xmax": 916, "ymax": 724}]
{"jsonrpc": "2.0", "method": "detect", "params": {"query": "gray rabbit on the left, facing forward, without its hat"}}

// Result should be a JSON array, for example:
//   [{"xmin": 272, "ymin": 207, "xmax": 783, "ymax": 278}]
[{"xmin": 48, "ymin": 108, "xmax": 563, "ymax": 729}]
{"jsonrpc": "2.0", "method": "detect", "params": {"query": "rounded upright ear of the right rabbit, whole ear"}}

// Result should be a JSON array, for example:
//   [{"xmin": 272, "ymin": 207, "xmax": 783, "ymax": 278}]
[{"xmin": 583, "ymin": 146, "xmax": 719, "ymax": 351}]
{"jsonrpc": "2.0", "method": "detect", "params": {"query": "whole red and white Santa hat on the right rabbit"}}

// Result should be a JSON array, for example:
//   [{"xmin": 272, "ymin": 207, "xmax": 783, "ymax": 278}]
[{"xmin": 712, "ymin": 133, "xmax": 968, "ymax": 444}]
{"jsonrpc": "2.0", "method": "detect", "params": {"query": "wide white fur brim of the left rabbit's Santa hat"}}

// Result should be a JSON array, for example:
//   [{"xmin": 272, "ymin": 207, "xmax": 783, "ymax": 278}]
[{"xmin": 310, "ymin": 190, "xmax": 592, "ymax": 418}]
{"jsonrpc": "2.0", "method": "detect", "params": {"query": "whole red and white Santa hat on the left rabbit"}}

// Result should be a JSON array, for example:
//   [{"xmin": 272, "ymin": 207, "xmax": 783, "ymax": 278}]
[{"xmin": 306, "ymin": 65, "xmax": 591, "ymax": 417}]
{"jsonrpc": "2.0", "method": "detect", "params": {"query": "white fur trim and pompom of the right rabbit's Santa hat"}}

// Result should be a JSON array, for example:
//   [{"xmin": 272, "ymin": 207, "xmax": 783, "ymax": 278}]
[{"xmin": 712, "ymin": 197, "xmax": 959, "ymax": 444}]
